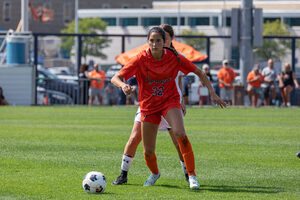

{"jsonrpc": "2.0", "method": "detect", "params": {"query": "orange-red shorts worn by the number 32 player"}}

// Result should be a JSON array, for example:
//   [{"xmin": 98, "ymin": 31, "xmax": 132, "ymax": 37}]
[{"xmin": 141, "ymin": 103, "xmax": 181, "ymax": 125}]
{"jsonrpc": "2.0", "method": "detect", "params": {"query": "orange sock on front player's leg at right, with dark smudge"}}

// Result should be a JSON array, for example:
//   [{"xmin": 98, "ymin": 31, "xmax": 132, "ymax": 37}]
[{"xmin": 177, "ymin": 136, "xmax": 196, "ymax": 176}]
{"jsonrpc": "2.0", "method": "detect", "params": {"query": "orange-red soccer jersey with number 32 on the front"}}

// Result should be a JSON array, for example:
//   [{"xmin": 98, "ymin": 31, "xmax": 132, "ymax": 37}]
[{"xmin": 119, "ymin": 49, "xmax": 197, "ymax": 115}]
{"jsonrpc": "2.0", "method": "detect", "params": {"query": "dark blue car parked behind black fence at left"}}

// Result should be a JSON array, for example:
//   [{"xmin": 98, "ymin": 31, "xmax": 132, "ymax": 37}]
[{"xmin": 37, "ymin": 67, "xmax": 78, "ymax": 104}]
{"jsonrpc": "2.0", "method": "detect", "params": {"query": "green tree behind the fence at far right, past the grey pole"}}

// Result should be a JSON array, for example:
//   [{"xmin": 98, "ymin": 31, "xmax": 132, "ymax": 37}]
[{"xmin": 254, "ymin": 20, "xmax": 292, "ymax": 60}]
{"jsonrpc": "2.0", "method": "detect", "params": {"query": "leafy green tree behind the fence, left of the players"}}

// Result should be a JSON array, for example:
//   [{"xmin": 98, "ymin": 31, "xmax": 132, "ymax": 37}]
[{"xmin": 61, "ymin": 18, "xmax": 111, "ymax": 62}]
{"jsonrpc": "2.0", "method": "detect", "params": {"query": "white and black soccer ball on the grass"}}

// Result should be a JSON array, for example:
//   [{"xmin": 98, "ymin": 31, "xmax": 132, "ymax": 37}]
[{"xmin": 82, "ymin": 171, "xmax": 107, "ymax": 194}]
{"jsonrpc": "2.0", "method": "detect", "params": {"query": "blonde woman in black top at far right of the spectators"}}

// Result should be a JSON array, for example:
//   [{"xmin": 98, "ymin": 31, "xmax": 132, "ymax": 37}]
[{"xmin": 278, "ymin": 63, "xmax": 299, "ymax": 106}]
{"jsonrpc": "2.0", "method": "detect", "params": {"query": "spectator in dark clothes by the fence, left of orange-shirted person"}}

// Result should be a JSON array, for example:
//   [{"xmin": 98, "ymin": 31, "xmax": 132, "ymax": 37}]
[{"xmin": 78, "ymin": 64, "xmax": 90, "ymax": 105}]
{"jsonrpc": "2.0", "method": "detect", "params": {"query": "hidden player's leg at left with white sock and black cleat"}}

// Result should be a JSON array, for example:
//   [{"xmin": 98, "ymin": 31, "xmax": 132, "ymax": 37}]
[{"xmin": 112, "ymin": 121, "xmax": 142, "ymax": 185}]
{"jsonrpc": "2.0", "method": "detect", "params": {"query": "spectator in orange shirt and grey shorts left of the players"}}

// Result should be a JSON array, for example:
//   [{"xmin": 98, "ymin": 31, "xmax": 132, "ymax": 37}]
[{"xmin": 89, "ymin": 64, "xmax": 106, "ymax": 105}]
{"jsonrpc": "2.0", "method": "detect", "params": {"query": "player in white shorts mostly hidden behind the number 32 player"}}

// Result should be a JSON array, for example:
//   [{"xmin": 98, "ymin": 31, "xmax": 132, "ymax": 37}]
[{"xmin": 112, "ymin": 24, "xmax": 189, "ymax": 185}]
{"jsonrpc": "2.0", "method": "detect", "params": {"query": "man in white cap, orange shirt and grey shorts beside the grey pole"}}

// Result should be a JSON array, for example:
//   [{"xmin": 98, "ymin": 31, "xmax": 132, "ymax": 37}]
[{"xmin": 217, "ymin": 60, "xmax": 236, "ymax": 105}]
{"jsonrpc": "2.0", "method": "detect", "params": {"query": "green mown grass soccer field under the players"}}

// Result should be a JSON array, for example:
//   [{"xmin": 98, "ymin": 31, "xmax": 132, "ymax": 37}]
[{"xmin": 0, "ymin": 107, "xmax": 300, "ymax": 200}]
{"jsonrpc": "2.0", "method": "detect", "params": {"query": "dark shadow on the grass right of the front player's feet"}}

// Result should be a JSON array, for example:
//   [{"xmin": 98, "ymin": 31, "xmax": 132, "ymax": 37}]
[{"xmin": 200, "ymin": 185, "xmax": 284, "ymax": 194}]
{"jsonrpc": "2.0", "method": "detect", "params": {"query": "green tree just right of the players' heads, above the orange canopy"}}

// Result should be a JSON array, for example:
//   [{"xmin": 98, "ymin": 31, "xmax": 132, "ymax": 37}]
[{"xmin": 181, "ymin": 30, "xmax": 213, "ymax": 51}]
